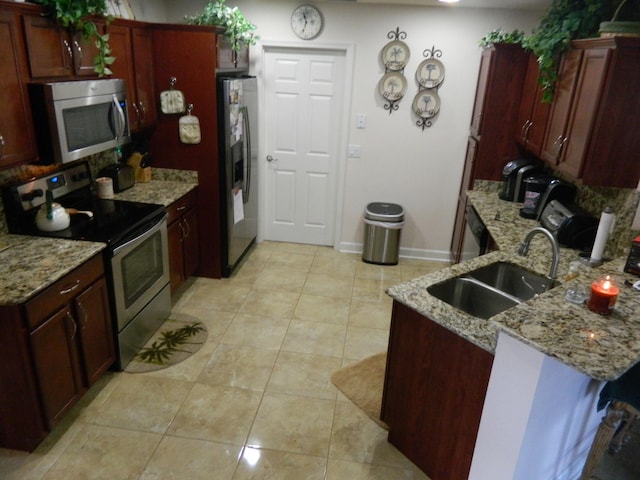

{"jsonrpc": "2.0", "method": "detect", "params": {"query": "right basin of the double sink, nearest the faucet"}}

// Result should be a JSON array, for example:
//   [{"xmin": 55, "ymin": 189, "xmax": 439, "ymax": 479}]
[{"xmin": 467, "ymin": 262, "xmax": 554, "ymax": 300}]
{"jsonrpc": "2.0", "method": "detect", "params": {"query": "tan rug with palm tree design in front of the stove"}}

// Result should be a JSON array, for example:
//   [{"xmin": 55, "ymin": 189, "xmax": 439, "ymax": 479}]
[{"xmin": 124, "ymin": 314, "xmax": 208, "ymax": 373}]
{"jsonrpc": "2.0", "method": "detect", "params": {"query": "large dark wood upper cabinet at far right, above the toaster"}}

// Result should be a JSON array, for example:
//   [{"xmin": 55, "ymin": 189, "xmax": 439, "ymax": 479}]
[{"xmin": 541, "ymin": 37, "xmax": 640, "ymax": 188}]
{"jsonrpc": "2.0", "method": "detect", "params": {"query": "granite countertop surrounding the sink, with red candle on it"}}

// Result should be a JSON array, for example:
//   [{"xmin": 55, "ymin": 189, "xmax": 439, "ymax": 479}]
[{"xmin": 388, "ymin": 191, "xmax": 640, "ymax": 381}]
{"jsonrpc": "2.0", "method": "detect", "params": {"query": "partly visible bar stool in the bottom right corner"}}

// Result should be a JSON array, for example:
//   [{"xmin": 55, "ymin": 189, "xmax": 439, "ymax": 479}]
[{"xmin": 580, "ymin": 363, "xmax": 640, "ymax": 480}]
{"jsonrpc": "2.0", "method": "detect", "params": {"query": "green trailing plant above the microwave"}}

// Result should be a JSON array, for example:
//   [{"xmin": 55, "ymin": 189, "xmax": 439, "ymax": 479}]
[{"xmin": 35, "ymin": 0, "xmax": 115, "ymax": 77}]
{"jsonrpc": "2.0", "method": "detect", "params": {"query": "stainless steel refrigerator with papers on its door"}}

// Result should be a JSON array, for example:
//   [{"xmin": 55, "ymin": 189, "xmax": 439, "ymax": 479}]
[{"xmin": 217, "ymin": 76, "xmax": 258, "ymax": 277}]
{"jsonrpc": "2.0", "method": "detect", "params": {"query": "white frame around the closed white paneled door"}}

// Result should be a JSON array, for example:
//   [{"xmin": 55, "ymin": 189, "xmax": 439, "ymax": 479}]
[{"xmin": 252, "ymin": 40, "xmax": 355, "ymax": 250}]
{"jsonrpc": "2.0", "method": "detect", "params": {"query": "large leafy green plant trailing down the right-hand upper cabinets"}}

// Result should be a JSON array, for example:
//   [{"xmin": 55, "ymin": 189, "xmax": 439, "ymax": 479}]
[{"xmin": 523, "ymin": 0, "xmax": 627, "ymax": 103}]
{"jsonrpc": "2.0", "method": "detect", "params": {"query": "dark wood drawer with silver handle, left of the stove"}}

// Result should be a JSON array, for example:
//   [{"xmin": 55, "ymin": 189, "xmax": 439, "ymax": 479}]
[{"xmin": 25, "ymin": 255, "xmax": 104, "ymax": 329}]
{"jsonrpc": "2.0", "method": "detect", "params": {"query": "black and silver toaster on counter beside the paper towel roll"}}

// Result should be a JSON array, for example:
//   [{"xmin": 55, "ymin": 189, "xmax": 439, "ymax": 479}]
[{"xmin": 540, "ymin": 200, "xmax": 598, "ymax": 251}]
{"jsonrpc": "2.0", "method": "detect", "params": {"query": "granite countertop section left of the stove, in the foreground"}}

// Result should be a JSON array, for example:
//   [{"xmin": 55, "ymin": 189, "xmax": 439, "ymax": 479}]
[{"xmin": 0, "ymin": 234, "xmax": 106, "ymax": 305}]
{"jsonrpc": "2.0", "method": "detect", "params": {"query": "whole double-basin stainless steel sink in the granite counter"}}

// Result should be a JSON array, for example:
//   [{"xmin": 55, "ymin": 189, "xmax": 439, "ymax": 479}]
[{"xmin": 427, "ymin": 262, "xmax": 555, "ymax": 319}]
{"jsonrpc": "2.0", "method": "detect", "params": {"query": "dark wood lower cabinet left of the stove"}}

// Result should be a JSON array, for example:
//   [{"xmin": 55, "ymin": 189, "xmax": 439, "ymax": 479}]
[{"xmin": 0, "ymin": 255, "xmax": 116, "ymax": 450}]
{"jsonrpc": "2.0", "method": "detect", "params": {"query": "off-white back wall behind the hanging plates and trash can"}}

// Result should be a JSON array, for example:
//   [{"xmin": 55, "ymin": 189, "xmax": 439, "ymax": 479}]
[{"xmin": 139, "ymin": 0, "xmax": 540, "ymax": 260}]
